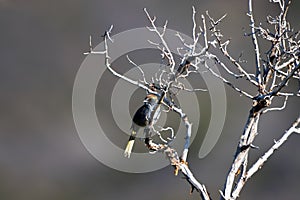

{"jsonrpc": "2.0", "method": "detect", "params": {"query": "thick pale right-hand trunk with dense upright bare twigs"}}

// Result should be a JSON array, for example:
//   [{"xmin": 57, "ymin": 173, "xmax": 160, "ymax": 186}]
[{"xmin": 214, "ymin": 0, "xmax": 300, "ymax": 200}]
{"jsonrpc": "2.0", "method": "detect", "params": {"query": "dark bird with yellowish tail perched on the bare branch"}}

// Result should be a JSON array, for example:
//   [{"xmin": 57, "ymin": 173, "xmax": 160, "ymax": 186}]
[{"xmin": 124, "ymin": 93, "xmax": 160, "ymax": 158}]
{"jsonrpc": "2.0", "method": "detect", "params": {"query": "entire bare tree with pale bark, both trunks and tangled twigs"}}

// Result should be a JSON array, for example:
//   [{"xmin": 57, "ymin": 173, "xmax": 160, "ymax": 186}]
[{"xmin": 87, "ymin": 0, "xmax": 300, "ymax": 200}]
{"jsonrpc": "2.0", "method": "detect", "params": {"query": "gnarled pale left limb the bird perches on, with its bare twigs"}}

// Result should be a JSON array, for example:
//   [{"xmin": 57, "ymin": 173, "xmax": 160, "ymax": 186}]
[{"xmin": 84, "ymin": 9, "xmax": 210, "ymax": 200}]
